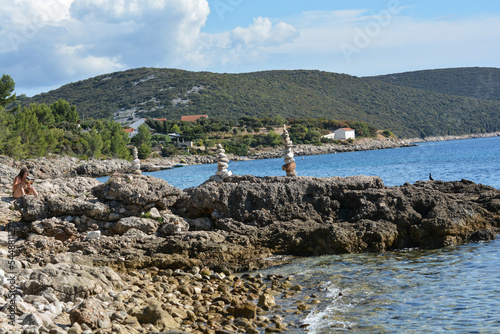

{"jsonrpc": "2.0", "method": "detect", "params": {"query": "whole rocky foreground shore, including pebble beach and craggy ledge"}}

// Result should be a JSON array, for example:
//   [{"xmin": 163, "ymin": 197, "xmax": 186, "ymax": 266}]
[{"xmin": 0, "ymin": 164, "xmax": 500, "ymax": 334}]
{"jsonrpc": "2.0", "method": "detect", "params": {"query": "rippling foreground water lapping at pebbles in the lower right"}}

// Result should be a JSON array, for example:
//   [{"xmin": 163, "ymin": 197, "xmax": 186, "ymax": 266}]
[{"xmin": 256, "ymin": 239, "xmax": 500, "ymax": 333}]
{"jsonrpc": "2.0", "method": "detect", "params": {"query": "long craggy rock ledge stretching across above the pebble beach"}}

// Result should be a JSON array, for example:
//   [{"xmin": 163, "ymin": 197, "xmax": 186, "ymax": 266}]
[{"xmin": 9, "ymin": 174, "xmax": 500, "ymax": 270}]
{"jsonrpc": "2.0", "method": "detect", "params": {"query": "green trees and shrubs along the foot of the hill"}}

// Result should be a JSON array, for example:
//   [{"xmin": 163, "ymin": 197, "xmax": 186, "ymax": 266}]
[{"xmin": 0, "ymin": 75, "xmax": 377, "ymax": 159}]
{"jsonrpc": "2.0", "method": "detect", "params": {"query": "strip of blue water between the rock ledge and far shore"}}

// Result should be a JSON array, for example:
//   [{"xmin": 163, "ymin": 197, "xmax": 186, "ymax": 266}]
[{"xmin": 141, "ymin": 137, "xmax": 500, "ymax": 189}]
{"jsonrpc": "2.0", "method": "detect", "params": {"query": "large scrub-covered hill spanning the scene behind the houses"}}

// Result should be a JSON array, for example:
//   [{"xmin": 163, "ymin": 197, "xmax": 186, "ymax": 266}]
[{"xmin": 21, "ymin": 68, "xmax": 500, "ymax": 137}]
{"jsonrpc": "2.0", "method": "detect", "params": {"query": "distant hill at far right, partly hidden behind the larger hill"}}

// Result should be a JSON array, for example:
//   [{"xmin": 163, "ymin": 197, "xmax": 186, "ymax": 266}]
[{"xmin": 367, "ymin": 67, "xmax": 500, "ymax": 101}]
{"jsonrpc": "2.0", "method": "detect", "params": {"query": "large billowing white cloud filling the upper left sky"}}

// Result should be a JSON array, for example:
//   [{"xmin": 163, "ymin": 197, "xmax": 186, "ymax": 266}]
[{"xmin": 0, "ymin": 0, "xmax": 210, "ymax": 93}]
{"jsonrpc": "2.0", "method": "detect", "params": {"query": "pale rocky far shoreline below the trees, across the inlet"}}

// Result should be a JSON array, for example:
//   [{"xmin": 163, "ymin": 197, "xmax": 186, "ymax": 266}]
[{"xmin": 0, "ymin": 132, "xmax": 500, "ymax": 184}]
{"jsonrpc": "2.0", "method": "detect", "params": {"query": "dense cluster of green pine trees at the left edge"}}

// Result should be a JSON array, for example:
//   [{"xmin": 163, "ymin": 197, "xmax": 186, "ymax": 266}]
[{"xmin": 0, "ymin": 74, "xmax": 130, "ymax": 159}]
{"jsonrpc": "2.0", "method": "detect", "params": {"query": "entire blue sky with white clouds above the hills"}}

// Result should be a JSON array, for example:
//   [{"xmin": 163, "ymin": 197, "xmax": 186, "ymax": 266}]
[{"xmin": 0, "ymin": 0, "xmax": 500, "ymax": 96}]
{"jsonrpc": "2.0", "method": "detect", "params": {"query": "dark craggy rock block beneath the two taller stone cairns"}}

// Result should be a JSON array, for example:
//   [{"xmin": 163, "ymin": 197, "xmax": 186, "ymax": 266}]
[{"xmin": 175, "ymin": 176, "xmax": 500, "ymax": 255}]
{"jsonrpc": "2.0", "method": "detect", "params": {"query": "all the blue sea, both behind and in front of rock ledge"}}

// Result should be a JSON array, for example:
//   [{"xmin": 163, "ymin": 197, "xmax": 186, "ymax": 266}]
[{"xmin": 130, "ymin": 137, "xmax": 500, "ymax": 333}]
